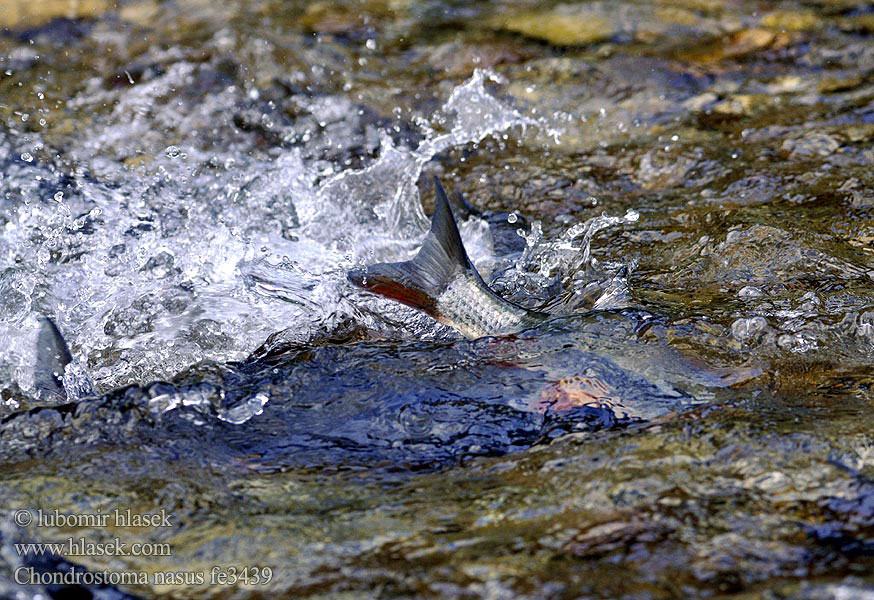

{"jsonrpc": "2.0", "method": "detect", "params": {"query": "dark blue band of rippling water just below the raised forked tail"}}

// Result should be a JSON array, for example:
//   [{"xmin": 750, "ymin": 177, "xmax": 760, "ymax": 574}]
[{"xmin": 0, "ymin": 311, "xmax": 725, "ymax": 472}]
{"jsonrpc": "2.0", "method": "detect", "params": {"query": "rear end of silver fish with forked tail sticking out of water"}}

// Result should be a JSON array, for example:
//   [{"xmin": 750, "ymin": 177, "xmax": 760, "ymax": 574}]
[{"xmin": 347, "ymin": 177, "xmax": 550, "ymax": 339}]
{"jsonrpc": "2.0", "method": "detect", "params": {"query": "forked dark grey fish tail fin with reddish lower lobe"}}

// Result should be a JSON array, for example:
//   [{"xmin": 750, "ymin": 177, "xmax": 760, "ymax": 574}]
[{"xmin": 348, "ymin": 177, "xmax": 478, "ymax": 314}]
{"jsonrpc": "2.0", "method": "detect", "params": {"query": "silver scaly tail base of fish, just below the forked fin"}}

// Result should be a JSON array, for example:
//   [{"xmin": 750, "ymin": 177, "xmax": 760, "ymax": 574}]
[{"xmin": 437, "ymin": 274, "xmax": 527, "ymax": 338}]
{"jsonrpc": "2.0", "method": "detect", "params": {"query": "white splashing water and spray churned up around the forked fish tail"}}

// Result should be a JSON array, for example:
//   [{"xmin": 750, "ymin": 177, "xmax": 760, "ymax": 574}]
[{"xmin": 0, "ymin": 66, "xmax": 629, "ymax": 392}]
